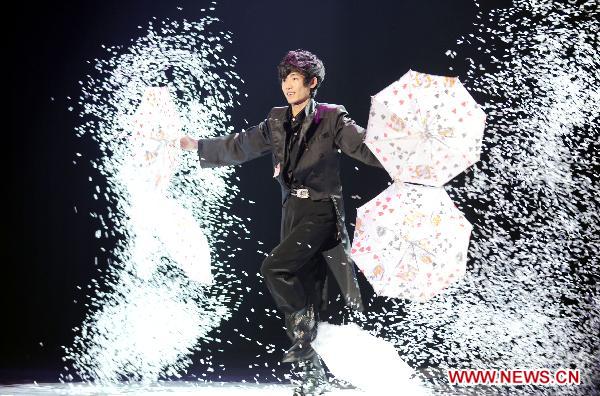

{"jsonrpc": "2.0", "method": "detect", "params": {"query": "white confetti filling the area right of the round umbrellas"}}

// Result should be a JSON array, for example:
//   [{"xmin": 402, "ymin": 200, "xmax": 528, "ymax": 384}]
[{"xmin": 350, "ymin": 0, "xmax": 600, "ymax": 395}]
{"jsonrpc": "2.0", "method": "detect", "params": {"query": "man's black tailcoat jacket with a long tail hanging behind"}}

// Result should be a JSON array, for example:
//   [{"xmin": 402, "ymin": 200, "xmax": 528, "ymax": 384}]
[{"xmin": 198, "ymin": 99, "xmax": 383, "ymax": 311}]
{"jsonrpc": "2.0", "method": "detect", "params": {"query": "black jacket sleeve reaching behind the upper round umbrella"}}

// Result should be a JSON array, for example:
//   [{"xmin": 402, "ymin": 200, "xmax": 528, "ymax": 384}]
[{"xmin": 335, "ymin": 106, "xmax": 383, "ymax": 168}]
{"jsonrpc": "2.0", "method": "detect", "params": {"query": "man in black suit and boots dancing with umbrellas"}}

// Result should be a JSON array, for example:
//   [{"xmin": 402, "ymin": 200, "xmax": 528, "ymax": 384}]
[{"xmin": 181, "ymin": 50, "xmax": 382, "ymax": 395}]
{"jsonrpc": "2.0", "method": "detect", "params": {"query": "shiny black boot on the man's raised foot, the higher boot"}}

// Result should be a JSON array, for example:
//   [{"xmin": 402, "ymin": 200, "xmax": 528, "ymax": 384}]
[{"xmin": 282, "ymin": 305, "xmax": 317, "ymax": 363}]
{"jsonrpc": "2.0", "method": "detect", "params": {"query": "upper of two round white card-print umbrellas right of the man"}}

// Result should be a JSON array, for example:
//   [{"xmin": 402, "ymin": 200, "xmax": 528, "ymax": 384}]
[{"xmin": 365, "ymin": 70, "xmax": 485, "ymax": 187}]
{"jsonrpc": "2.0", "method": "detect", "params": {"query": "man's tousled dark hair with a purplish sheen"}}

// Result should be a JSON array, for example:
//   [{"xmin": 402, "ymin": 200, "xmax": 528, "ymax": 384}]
[{"xmin": 277, "ymin": 49, "xmax": 325, "ymax": 98}]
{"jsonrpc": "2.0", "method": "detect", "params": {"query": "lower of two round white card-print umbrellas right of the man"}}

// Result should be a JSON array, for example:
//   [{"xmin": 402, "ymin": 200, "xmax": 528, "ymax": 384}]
[{"xmin": 351, "ymin": 183, "xmax": 472, "ymax": 301}]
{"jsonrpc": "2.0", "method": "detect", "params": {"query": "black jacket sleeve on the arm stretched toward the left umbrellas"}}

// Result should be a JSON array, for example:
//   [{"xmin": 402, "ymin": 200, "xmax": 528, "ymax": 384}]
[{"xmin": 198, "ymin": 120, "xmax": 271, "ymax": 168}]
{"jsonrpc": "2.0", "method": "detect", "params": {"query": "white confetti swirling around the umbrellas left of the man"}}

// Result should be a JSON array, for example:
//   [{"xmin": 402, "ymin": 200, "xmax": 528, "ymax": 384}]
[{"xmin": 63, "ymin": 16, "xmax": 248, "ymax": 383}]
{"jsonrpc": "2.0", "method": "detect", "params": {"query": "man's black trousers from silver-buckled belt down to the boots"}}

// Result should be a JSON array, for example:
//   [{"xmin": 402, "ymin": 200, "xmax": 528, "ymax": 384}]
[{"xmin": 260, "ymin": 195, "xmax": 337, "ymax": 313}]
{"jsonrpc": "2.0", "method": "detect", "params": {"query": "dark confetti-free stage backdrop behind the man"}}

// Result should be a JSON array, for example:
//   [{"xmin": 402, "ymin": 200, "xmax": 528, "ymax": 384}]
[{"xmin": 0, "ymin": 0, "xmax": 509, "ymax": 383}]
